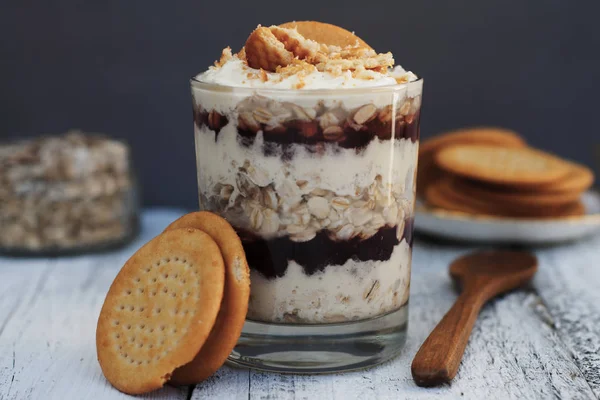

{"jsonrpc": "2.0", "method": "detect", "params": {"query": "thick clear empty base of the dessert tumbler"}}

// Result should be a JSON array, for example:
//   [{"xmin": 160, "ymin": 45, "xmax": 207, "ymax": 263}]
[{"xmin": 228, "ymin": 304, "xmax": 408, "ymax": 374}]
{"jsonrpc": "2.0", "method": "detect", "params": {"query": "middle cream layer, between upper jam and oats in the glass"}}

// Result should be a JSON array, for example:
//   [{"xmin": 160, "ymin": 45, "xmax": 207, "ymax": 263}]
[{"xmin": 196, "ymin": 122, "xmax": 419, "ymax": 195}]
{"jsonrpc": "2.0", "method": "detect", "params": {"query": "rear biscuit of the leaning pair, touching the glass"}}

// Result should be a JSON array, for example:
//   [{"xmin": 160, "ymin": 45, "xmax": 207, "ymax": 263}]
[{"xmin": 165, "ymin": 211, "xmax": 250, "ymax": 385}]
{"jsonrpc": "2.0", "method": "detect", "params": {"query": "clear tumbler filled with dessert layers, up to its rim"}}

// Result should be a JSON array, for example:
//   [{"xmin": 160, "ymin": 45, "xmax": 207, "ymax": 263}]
[{"xmin": 191, "ymin": 79, "xmax": 423, "ymax": 373}]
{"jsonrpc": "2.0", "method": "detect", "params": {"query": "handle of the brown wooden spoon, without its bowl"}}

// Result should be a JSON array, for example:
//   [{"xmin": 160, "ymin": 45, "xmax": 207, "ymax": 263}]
[{"xmin": 411, "ymin": 290, "xmax": 485, "ymax": 387}]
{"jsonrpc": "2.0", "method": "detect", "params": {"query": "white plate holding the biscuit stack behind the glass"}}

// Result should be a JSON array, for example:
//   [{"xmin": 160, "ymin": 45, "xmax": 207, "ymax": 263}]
[{"xmin": 415, "ymin": 191, "xmax": 600, "ymax": 244}]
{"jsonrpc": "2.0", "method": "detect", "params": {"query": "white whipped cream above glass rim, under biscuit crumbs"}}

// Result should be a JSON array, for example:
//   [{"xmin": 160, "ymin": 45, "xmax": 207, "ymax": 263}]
[{"xmin": 195, "ymin": 56, "xmax": 418, "ymax": 90}]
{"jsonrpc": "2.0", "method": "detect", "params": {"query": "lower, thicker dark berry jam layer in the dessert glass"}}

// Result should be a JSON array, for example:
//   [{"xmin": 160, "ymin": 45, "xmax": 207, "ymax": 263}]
[{"xmin": 240, "ymin": 219, "xmax": 414, "ymax": 278}]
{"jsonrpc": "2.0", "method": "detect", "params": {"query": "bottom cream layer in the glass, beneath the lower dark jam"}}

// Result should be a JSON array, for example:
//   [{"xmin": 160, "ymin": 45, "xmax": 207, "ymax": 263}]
[{"xmin": 248, "ymin": 240, "xmax": 411, "ymax": 323}]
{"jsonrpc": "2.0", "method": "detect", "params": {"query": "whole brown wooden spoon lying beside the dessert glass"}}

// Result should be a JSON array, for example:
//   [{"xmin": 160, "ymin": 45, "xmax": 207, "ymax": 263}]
[{"xmin": 411, "ymin": 251, "xmax": 537, "ymax": 387}]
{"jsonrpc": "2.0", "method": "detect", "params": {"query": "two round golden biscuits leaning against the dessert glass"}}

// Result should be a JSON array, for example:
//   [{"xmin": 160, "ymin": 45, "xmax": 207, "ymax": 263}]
[{"xmin": 96, "ymin": 212, "xmax": 250, "ymax": 394}]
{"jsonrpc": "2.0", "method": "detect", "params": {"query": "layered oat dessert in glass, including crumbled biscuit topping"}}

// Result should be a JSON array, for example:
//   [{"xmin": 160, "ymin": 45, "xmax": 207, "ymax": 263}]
[{"xmin": 192, "ymin": 23, "xmax": 422, "ymax": 370}]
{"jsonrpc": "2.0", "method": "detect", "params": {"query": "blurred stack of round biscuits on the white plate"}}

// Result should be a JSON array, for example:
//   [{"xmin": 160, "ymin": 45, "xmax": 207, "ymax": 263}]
[{"xmin": 417, "ymin": 128, "xmax": 594, "ymax": 218}]
